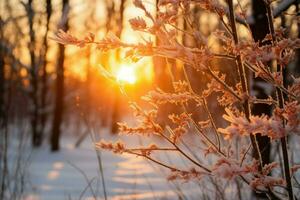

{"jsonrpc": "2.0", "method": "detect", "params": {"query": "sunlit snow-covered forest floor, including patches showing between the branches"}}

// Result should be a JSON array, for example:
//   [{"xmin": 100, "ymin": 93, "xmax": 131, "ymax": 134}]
[{"xmin": 10, "ymin": 123, "xmax": 299, "ymax": 200}]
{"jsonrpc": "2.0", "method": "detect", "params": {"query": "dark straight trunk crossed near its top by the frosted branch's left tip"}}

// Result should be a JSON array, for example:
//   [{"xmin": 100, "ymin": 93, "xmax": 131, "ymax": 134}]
[{"xmin": 51, "ymin": 0, "xmax": 69, "ymax": 151}]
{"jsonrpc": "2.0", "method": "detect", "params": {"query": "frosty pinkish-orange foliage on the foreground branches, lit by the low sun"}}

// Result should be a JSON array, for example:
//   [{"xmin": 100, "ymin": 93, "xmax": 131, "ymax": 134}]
[{"xmin": 53, "ymin": 0, "xmax": 300, "ymax": 199}]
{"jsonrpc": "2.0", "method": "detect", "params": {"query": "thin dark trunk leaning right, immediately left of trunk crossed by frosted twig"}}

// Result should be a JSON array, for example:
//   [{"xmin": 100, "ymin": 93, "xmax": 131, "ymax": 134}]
[{"xmin": 39, "ymin": 0, "xmax": 52, "ymax": 145}]
